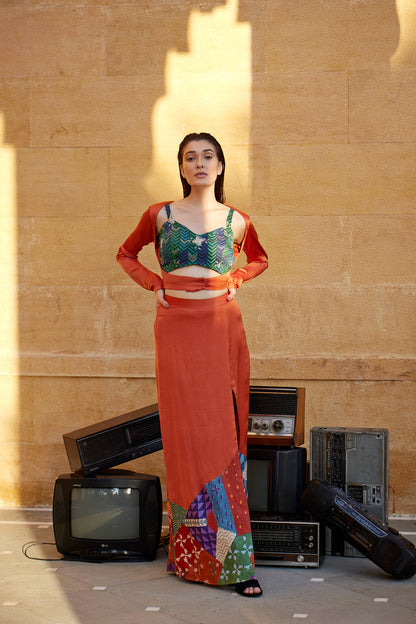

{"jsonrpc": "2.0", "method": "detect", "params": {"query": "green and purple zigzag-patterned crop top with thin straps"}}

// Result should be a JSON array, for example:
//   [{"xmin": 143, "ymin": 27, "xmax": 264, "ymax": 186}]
[{"xmin": 159, "ymin": 204, "xmax": 235, "ymax": 275}]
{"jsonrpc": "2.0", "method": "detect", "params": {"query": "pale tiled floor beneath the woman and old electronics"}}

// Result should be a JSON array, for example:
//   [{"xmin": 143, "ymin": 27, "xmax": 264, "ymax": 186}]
[{"xmin": 0, "ymin": 509, "xmax": 416, "ymax": 624}]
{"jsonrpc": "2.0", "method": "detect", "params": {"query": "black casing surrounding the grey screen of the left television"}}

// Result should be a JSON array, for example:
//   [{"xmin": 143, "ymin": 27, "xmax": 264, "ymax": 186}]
[{"xmin": 52, "ymin": 470, "xmax": 162, "ymax": 561}]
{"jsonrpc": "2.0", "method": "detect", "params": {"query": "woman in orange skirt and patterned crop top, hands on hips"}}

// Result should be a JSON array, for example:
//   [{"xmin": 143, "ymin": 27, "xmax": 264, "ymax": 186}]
[{"xmin": 117, "ymin": 133, "xmax": 267, "ymax": 597}]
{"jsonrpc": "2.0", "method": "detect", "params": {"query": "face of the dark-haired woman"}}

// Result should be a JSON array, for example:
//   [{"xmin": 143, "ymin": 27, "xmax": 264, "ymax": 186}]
[{"xmin": 180, "ymin": 140, "xmax": 222, "ymax": 187}]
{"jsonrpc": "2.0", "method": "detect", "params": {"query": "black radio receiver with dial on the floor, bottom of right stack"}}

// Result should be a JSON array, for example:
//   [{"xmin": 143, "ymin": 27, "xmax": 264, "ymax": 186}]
[{"xmin": 251, "ymin": 517, "xmax": 320, "ymax": 568}]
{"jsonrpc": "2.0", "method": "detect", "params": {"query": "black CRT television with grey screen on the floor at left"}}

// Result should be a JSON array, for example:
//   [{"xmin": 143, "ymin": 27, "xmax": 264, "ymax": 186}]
[{"xmin": 53, "ymin": 469, "xmax": 162, "ymax": 561}]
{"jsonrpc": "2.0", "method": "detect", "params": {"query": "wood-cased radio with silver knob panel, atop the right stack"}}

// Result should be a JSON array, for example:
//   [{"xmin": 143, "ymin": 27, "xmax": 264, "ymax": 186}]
[{"xmin": 247, "ymin": 386, "xmax": 305, "ymax": 446}]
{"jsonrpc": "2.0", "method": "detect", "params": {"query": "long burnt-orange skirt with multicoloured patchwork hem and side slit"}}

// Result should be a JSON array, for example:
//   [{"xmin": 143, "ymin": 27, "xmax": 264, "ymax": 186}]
[{"xmin": 155, "ymin": 295, "xmax": 254, "ymax": 584}]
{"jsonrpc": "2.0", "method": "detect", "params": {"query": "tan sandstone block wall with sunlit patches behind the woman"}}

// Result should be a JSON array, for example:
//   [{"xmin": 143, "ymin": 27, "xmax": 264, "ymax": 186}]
[{"xmin": 0, "ymin": 0, "xmax": 416, "ymax": 514}]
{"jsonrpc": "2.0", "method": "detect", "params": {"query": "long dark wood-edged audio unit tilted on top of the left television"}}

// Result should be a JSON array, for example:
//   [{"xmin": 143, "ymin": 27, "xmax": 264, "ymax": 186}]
[{"xmin": 63, "ymin": 403, "xmax": 162, "ymax": 476}]
